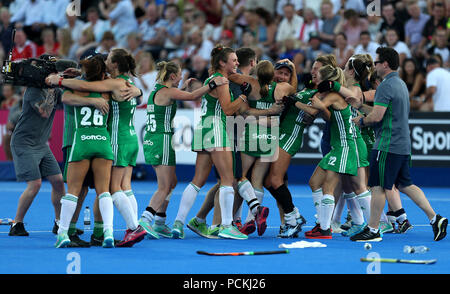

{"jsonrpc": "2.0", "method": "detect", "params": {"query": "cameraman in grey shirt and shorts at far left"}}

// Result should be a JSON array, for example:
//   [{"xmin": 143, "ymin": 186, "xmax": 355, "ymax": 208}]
[{"xmin": 9, "ymin": 54, "xmax": 76, "ymax": 236}]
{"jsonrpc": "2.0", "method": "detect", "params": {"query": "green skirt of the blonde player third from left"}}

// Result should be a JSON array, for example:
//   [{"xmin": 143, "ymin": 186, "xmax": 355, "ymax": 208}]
[{"xmin": 144, "ymin": 133, "xmax": 176, "ymax": 166}]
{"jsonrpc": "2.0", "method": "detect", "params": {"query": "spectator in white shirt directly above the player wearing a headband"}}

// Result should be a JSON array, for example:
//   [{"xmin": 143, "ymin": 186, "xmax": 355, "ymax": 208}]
[{"xmin": 275, "ymin": 3, "xmax": 303, "ymax": 48}]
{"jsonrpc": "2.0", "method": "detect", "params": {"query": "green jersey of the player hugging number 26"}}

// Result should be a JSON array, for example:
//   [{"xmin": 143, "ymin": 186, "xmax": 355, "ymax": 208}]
[{"xmin": 108, "ymin": 75, "xmax": 137, "ymax": 144}]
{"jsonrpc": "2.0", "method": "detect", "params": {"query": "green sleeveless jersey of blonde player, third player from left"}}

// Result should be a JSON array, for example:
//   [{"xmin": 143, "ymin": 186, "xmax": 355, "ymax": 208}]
[{"xmin": 145, "ymin": 83, "xmax": 177, "ymax": 134}]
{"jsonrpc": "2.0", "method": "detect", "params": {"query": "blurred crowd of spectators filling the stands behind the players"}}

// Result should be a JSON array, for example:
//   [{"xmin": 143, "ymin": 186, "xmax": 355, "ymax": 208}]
[{"xmin": 0, "ymin": 0, "xmax": 450, "ymax": 111}]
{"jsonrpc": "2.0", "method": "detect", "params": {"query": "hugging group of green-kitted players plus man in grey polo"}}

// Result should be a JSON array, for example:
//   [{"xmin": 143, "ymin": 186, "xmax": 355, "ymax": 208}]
[{"xmin": 10, "ymin": 45, "xmax": 448, "ymax": 248}]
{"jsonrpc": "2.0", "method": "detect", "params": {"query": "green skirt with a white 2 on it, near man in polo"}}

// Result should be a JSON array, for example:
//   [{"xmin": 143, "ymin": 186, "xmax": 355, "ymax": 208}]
[{"xmin": 319, "ymin": 144, "xmax": 358, "ymax": 176}]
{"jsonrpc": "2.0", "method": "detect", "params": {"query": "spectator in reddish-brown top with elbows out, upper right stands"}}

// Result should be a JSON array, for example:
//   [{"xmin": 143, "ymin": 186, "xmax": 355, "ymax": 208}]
[{"xmin": 335, "ymin": 9, "xmax": 369, "ymax": 47}]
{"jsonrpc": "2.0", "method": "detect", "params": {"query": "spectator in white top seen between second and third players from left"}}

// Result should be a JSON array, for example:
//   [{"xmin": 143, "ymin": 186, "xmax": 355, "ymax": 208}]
[{"xmin": 133, "ymin": 51, "xmax": 158, "ymax": 107}]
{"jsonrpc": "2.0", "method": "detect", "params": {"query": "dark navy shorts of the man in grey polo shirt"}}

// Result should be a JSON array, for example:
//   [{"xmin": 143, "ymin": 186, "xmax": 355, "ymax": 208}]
[{"xmin": 368, "ymin": 149, "xmax": 412, "ymax": 190}]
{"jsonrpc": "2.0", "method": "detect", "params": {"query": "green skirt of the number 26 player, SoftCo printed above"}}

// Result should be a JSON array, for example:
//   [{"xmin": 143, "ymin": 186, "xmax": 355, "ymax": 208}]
[{"xmin": 69, "ymin": 128, "xmax": 114, "ymax": 162}]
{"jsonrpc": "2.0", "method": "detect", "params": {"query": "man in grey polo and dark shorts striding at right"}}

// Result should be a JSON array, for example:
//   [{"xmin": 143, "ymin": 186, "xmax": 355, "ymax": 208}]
[{"xmin": 349, "ymin": 47, "xmax": 448, "ymax": 242}]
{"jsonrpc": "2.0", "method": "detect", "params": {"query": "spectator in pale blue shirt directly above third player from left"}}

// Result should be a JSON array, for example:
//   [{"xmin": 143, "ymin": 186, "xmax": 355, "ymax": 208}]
[{"xmin": 159, "ymin": 4, "xmax": 183, "ymax": 59}]
